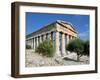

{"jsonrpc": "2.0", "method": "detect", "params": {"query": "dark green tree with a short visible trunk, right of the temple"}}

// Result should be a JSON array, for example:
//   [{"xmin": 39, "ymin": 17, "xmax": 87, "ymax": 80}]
[{"xmin": 66, "ymin": 39, "xmax": 85, "ymax": 61}]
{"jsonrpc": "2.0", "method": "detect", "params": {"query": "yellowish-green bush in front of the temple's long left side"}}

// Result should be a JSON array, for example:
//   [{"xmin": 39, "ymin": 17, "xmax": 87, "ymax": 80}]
[{"xmin": 35, "ymin": 40, "xmax": 54, "ymax": 57}]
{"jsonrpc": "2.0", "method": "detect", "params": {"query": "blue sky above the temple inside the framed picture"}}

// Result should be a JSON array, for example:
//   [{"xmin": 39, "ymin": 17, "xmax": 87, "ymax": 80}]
[{"xmin": 26, "ymin": 12, "xmax": 89, "ymax": 40}]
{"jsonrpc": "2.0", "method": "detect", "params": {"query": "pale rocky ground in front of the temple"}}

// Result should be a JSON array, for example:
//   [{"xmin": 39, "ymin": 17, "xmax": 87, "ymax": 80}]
[{"xmin": 25, "ymin": 50, "xmax": 89, "ymax": 67}]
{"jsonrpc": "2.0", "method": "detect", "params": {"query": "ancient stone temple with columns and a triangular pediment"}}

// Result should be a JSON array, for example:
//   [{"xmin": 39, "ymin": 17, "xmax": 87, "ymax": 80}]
[{"xmin": 26, "ymin": 20, "xmax": 77, "ymax": 56}]
